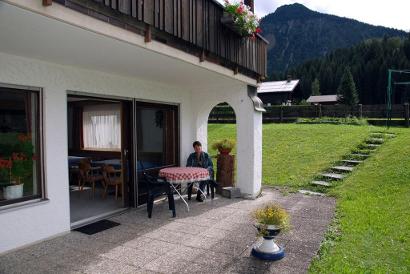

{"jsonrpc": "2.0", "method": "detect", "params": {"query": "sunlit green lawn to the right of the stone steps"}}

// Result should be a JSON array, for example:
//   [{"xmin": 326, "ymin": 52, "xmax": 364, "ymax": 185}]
[{"xmin": 310, "ymin": 129, "xmax": 410, "ymax": 273}]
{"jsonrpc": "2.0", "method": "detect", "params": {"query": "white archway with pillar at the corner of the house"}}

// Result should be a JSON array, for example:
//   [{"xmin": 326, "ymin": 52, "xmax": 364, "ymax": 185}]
[{"xmin": 192, "ymin": 85, "xmax": 262, "ymax": 198}]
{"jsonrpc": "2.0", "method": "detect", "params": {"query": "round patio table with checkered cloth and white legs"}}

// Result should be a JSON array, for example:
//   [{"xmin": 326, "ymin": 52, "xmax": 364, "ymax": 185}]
[{"xmin": 159, "ymin": 167, "xmax": 210, "ymax": 211}]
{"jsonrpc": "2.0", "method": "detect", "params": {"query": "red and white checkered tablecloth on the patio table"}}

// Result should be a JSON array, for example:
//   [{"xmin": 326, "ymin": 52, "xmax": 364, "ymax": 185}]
[{"xmin": 159, "ymin": 167, "xmax": 209, "ymax": 184}]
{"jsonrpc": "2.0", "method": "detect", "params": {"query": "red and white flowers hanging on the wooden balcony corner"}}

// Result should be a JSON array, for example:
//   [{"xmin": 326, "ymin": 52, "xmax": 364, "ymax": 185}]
[{"xmin": 221, "ymin": 0, "xmax": 261, "ymax": 38}]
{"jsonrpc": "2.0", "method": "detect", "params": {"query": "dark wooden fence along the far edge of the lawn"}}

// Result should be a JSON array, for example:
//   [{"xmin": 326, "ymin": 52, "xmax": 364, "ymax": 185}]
[{"xmin": 209, "ymin": 104, "xmax": 409, "ymax": 126}]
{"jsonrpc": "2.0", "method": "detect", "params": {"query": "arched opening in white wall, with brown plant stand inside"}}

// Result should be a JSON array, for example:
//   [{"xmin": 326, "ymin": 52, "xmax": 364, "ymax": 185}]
[{"xmin": 207, "ymin": 102, "xmax": 237, "ymax": 191}]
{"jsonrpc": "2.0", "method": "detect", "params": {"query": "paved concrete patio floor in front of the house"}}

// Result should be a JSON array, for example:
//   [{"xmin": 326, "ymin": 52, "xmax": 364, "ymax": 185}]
[{"xmin": 0, "ymin": 188, "xmax": 335, "ymax": 274}]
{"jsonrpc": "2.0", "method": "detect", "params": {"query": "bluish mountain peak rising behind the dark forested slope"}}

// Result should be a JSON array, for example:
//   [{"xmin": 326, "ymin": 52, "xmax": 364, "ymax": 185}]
[{"xmin": 260, "ymin": 4, "xmax": 407, "ymax": 76}]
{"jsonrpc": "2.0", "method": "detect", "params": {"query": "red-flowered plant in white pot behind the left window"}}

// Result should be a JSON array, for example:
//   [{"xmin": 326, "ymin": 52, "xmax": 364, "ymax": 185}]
[{"xmin": 0, "ymin": 135, "xmax": 34, "ymax": 200}]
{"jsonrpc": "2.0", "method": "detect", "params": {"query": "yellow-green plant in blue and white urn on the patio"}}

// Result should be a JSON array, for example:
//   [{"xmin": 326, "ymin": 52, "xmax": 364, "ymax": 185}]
[{"xmin": 252, "ymin": 203, "xmax": 289, "ymax": 261}]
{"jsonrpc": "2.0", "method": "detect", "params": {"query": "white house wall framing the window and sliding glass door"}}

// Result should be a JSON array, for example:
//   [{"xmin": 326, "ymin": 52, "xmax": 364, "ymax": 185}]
[{"xmin": 0, "ymin": 52, "xmax": 194, "ymax": 253}]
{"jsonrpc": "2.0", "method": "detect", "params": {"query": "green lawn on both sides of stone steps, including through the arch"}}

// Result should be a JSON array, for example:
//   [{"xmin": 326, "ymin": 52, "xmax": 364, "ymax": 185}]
[{"xmin": 209, "ymin": 124, "xmax": 410, "ymax": 273}]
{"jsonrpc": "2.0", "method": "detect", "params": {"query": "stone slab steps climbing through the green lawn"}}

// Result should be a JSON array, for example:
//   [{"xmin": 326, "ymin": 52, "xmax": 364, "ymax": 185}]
[{"xmin": 299, "ymin": 132, "xmax": 396, "ymax": 195}]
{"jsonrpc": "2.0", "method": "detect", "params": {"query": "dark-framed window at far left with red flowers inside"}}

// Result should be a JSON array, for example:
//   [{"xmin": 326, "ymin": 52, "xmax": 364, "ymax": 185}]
[{"xmin": 0, "ymin": 87, "xmax": 42, "ymax": 206}]
